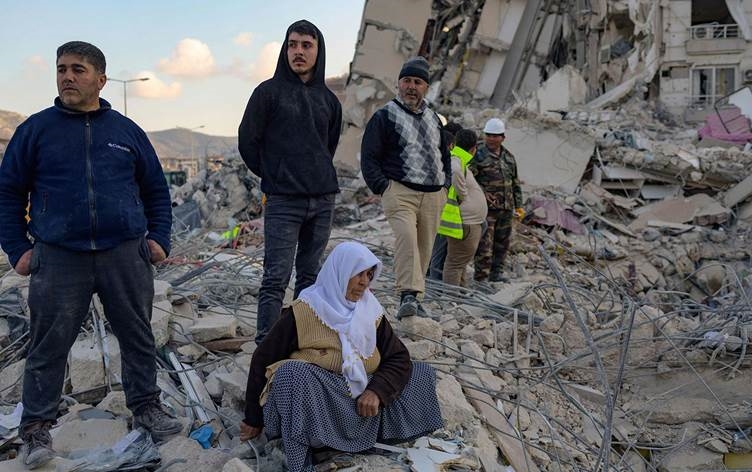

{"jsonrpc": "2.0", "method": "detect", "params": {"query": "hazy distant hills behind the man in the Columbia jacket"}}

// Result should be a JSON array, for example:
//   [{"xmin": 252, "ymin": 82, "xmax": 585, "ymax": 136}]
[{"xmin": 0, "ymin": 110, "xmax": 238, "ymax": 159}]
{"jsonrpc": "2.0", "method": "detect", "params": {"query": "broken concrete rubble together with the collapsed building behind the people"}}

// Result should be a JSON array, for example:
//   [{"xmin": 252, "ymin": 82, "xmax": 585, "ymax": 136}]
[{"xmin": 0, "ymin": 0, "xmax": 752, "ymax": 472}]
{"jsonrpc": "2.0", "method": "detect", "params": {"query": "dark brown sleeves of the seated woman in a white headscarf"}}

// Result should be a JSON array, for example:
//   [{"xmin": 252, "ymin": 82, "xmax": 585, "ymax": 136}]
[{"xmin": 243, "ymin": 306, "xmax": 412, "ymax": 426}]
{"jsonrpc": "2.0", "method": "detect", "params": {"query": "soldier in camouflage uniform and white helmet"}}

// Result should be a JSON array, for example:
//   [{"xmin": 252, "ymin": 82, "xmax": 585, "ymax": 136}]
[{"xmin": 470, "ymin": 118, "xmax": 525, "ymax": 282}]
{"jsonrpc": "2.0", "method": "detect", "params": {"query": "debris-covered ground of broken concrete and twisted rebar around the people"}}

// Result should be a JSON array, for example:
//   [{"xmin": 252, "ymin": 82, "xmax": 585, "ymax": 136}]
[{"xmin": 0, "ymin": 93, "xmax": 752, "ymax": 471}]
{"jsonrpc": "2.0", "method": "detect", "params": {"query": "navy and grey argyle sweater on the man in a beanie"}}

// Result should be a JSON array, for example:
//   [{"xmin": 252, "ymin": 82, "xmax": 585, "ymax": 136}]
[{"xmin": 360, "ymin": 98, "xmax": 452, "ymax": 195}]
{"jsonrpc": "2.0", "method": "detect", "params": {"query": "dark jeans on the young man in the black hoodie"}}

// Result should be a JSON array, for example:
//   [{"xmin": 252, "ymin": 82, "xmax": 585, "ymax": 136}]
[{"xmin": 256, "ymin": 194, "xmax": 334, "ymax": 344}]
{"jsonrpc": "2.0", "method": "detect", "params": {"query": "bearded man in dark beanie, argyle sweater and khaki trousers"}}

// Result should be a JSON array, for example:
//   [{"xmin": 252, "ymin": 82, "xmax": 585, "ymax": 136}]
[{"xmin": 360, "ymin": 57, "xmax": 452, "ymax": 319}]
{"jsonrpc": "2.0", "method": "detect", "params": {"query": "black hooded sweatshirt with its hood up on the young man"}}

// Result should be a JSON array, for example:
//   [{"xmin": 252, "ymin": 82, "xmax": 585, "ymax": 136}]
[{"xmin": 238, "ymin": 23, "xmax": 342, "ymax": 196}]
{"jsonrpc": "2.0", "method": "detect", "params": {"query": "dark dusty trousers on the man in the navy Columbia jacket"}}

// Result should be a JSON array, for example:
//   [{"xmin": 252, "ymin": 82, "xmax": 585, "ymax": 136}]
[{"xmin": 21, "ymin": 238, "xmax": 159, "ymax": 427}]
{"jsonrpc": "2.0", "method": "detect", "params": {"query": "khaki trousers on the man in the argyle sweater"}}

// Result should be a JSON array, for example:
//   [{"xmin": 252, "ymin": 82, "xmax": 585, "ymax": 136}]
[{"xmin": 381, "ymin": 180, "xmax": 446, "ymax": 293}]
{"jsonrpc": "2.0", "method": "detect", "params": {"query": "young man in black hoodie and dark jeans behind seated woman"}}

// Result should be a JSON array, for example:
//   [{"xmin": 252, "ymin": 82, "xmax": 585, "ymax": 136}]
[{"xmin": 238, "ymin": 20, "xmax": 342, "ymax": 343}]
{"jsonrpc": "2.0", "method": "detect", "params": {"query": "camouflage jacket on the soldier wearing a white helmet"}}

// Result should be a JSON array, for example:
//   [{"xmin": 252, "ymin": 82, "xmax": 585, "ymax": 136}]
[{"xmin": 470, "ymin": 144, "xmax": 522, "ymax": 210}]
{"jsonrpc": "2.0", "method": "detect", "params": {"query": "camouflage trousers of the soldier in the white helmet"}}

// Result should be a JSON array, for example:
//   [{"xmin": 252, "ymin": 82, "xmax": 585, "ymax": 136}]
[{"xmin": 475, "ymin": 210, "xmax": 514, "ymax": 281}]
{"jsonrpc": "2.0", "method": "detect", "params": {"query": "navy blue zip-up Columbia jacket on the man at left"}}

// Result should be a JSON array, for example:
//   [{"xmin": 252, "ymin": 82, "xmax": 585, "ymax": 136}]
[{"xmin": 0, "ymin": 98, "xmax": 172, "ymax": 266}]
